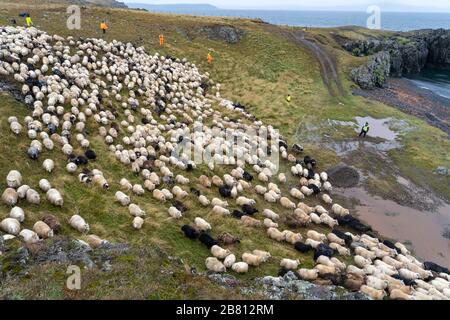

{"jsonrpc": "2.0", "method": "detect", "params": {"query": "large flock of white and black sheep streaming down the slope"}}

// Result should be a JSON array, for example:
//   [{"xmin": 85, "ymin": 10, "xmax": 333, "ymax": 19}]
[{"xmin": 0, "ymin": 27, "xmax": 450, "ymax": 300}]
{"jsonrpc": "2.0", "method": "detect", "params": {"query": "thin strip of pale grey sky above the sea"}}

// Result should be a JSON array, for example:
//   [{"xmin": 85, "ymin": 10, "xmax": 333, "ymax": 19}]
[{"xmin": 119, "ymin": 0, "xmax": 450, "ymax": 11}]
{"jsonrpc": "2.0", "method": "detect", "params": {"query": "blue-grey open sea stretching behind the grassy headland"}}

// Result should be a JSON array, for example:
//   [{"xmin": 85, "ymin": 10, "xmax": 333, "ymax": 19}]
[{"xmin": 127, "ymin": 3, "xmax": 450, "ymax": 31}]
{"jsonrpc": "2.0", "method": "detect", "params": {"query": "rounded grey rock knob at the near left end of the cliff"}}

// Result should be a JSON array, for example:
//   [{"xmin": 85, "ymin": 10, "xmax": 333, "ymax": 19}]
[{"xmin": 350, "ymin": 51, "xmax": 391, "ymax": 89}]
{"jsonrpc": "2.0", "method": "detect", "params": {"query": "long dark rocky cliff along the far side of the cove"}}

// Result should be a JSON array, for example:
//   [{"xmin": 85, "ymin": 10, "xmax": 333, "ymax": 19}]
[{"xmin": 343, "ymin": 29, "xmax": 450, "ymax": 88}]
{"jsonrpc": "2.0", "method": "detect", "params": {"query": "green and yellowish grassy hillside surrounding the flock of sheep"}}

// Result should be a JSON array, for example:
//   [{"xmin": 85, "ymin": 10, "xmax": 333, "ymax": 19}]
[{"xmin": 0, "ymin": 0, "xmax": 450, "ymax": 298}]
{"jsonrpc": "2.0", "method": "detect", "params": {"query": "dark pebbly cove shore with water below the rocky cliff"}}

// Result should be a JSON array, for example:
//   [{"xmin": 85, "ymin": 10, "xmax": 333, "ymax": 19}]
[{"xmin": 353, "ymin": 78, "xmax": 450, "ymax": 138}]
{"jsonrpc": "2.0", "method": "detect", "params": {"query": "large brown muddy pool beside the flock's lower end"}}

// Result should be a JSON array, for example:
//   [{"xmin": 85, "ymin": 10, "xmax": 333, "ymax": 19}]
[{"xmin": 336, "ymin": 188, "xmax": 450, "ymax": 267}]
